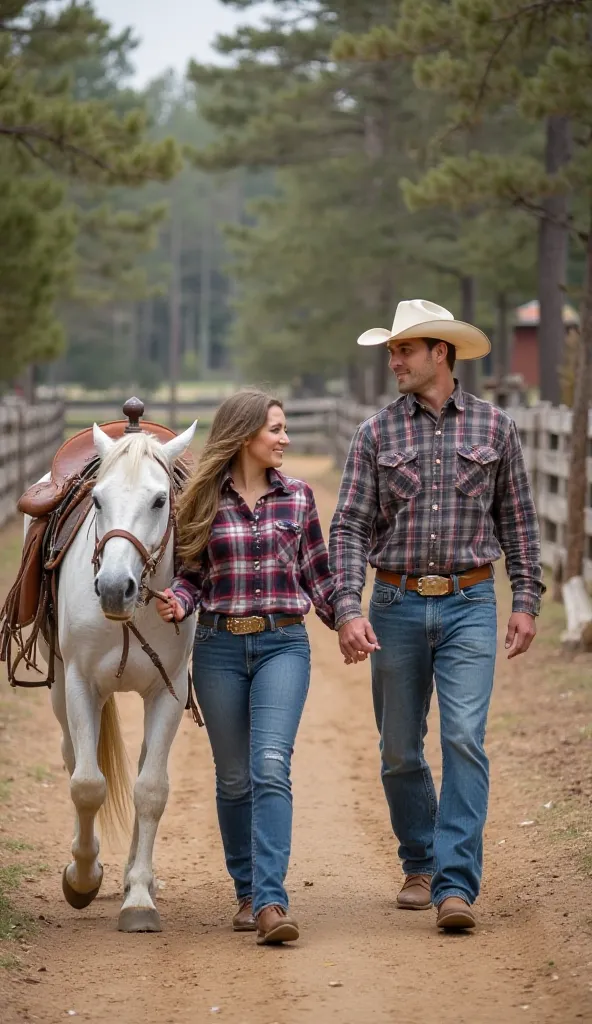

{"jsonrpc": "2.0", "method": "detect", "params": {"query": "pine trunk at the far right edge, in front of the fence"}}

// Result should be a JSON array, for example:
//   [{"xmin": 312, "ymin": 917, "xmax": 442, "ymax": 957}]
[{"xmin": 565, "ymin": 219, "xmax": 592, "ymax": 581}]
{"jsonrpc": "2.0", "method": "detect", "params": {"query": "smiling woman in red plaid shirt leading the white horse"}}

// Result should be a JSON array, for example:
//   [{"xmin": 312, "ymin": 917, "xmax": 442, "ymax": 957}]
[{"xmin": 158, "ymin": 389, "xmax": 334, "ymax": 944}]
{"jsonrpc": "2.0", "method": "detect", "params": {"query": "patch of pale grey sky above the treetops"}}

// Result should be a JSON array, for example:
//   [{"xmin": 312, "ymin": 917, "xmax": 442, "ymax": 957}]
[{"xmin": 94, "ymin": 0, "xmax": 270, "ymax": 87}]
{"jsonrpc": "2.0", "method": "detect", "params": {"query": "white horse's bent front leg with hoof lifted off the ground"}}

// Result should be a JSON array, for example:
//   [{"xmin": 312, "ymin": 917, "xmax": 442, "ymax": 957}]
[{"xmin": 61, "ymin": 666, "xmax": 107, "ymax": 910}]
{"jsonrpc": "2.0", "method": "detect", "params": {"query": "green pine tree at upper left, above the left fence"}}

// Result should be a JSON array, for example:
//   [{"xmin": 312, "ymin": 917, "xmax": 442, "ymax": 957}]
[{"xmin": 0, "ymin": 0, "xmax": 178, "ymax": 380}]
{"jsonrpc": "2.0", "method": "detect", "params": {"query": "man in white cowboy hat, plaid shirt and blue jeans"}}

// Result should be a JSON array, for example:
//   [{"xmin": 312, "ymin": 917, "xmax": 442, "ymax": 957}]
[{"xmin": 330, "ymin": 299, "xmax": 545, "ymax": 929}]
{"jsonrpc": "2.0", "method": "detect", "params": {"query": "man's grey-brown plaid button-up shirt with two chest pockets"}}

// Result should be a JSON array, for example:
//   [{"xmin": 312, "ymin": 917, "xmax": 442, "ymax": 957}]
[{"xmin": 329, "ymin": 381, "xmax": 545, "ymax": 629}]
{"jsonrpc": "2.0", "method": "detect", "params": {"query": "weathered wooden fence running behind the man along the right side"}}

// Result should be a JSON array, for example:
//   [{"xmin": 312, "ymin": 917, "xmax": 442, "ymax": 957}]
[{"xmin": 329, "ymin": 401, "xmax": 592, "ymax": 580}]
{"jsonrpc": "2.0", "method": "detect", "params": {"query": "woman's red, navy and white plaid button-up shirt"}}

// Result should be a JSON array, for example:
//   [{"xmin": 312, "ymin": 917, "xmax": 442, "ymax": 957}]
[{"xmin": 171, "ymin": 469, "xmax": 335, "ymax": 629}]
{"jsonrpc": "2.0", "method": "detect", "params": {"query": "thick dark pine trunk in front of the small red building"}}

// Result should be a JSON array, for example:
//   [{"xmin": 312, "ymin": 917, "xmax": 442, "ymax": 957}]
[{"xmin": 538, "ymin": 116, "xmax": 572, "ymax": 406}]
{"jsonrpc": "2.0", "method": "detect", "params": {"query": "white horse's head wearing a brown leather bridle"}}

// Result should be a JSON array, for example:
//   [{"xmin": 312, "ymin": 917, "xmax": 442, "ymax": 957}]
[{"xmin": 92, "ymin": 423, "xmax": 196, "ymax": 621}]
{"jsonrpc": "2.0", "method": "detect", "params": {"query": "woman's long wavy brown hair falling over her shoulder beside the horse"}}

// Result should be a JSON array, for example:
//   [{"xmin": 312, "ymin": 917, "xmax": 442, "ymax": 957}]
[{"xmin": 177, "ymin": 388, "xmax": 283, "ymax": 566}]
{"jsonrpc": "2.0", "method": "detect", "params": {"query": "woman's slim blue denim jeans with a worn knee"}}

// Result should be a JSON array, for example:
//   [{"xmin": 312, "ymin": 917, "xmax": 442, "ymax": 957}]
[{"xmin": 194, "ymin": 624, "xmax": 310, "ymax": 913}]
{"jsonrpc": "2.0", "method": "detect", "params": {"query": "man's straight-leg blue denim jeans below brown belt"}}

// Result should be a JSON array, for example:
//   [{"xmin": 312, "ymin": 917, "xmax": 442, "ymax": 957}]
[{"xmin": 370, "ymin": 580, "xmax": 497, "ymax": 906}]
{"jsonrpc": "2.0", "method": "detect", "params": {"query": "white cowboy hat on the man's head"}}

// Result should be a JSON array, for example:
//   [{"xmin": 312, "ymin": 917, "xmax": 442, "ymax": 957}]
[{"xmin": 357, "ymin": 299, "xmax": 492, "ymax": 359}]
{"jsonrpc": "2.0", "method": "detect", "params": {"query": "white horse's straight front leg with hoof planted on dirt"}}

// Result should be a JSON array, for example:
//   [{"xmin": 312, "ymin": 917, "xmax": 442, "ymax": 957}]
[{"xmin": 118, "ymin": 678, "xmax": 184, "ymax": 932}]
